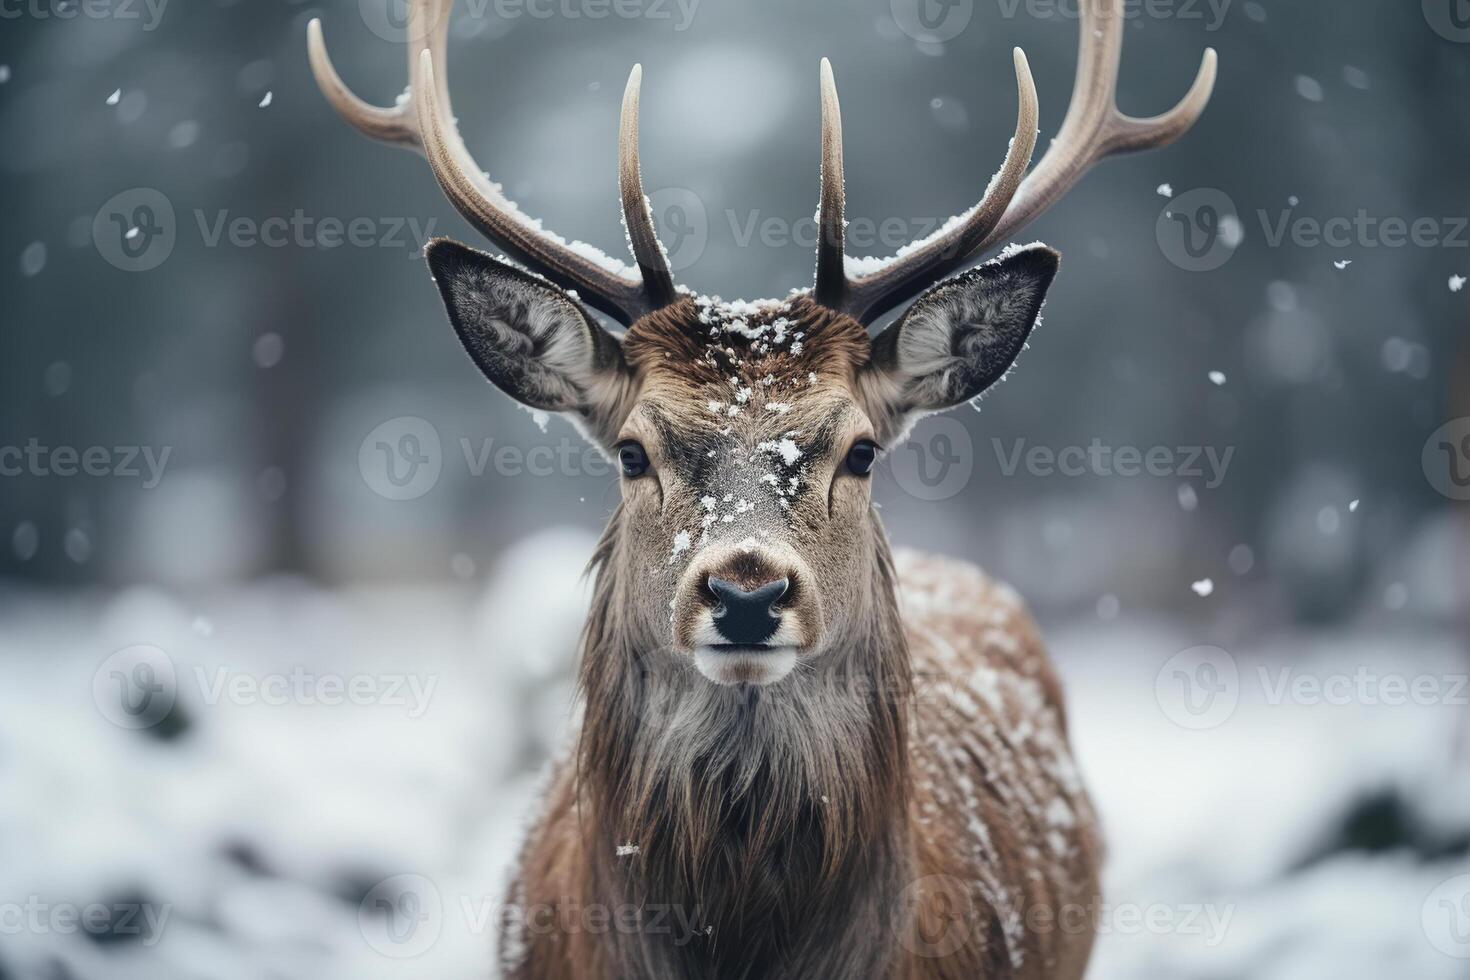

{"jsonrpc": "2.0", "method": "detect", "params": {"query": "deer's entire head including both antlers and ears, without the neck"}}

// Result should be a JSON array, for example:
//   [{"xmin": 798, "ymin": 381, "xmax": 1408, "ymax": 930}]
[{"xmin": 310, "ymin": 0, "xmax": 1216, "ymax": 685}]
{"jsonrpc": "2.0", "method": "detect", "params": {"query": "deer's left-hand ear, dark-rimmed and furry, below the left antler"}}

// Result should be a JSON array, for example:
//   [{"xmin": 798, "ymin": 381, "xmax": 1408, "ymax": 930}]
[{"xmin": 425, "ymin": 238, "xmax": 631, "ymax": 445}]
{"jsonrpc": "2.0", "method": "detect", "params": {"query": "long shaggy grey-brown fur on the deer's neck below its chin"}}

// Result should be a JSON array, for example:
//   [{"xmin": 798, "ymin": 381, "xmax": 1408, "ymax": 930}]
[{"xmin": 578, "ymin": 510, "xmax": 911, "ymax": 980}]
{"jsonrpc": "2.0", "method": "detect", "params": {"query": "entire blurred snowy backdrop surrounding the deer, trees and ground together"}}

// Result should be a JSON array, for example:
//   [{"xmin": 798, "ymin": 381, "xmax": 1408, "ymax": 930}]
[{"xmin": 0, "ymin": 0, "xmax": 1470, "ymax": 980}]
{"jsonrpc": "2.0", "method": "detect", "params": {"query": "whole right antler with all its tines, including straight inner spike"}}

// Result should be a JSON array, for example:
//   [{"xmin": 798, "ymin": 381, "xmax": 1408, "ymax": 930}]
[{"xmin": 814, "ymin": 0, "xmax": 1216, "ymax": 323}]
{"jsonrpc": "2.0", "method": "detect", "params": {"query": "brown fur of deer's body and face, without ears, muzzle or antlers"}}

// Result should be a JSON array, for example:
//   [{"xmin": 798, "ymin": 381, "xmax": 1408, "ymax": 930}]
[{"xmin": 501, "ymin": 297, "xmax": 1098, "ymax": 980}]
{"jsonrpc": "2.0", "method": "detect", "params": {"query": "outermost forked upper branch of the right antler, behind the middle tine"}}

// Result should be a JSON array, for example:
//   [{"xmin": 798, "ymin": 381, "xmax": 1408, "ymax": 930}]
[{"xmin": 980, "ymin": 0, "xmax": 1219, "ymax": 250}]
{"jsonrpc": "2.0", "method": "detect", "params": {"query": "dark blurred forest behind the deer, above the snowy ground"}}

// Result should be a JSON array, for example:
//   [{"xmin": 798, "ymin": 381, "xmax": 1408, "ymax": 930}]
[{"xmin": 0, "ymin": 0, "xmax": 1470, "ymax": 620}]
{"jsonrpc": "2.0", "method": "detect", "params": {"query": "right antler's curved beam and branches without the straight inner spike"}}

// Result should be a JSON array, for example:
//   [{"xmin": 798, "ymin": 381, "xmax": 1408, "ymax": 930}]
[{"xmin": 841, "ymin": 0, "xmax": 1217, "ymax": 323}]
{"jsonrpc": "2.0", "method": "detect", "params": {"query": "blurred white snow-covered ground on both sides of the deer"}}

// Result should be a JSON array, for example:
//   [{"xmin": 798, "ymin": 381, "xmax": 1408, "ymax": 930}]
[{"xmin": 0, "ymin": 532, "xmax": 1470, "ymax": 980}]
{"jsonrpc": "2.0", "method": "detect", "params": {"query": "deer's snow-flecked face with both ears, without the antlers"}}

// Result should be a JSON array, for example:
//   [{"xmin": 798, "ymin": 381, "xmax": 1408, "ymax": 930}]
[{"xmin": 428, "ymin": 239, "xmax": 1058, "ymax": 685}]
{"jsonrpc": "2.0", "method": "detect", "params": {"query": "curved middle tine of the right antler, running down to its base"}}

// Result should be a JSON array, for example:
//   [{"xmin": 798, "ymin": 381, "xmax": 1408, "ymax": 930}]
[{"xmin": 823, "ymin": 47, "xmax": 1038, "ymax": 323}]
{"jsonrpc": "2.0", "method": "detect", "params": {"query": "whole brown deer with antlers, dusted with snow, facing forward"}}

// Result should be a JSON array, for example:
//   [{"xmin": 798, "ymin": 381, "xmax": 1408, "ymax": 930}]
[{"xmin": 307, "ymin": 0, "xmax": 1216, "ymax": 980}]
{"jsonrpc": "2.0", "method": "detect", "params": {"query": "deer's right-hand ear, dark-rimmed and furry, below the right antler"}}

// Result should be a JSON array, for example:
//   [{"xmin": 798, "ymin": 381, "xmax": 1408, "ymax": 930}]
[{"xmin": 866, "ymin": 244, "xmax": 1061, "ymax": 433}]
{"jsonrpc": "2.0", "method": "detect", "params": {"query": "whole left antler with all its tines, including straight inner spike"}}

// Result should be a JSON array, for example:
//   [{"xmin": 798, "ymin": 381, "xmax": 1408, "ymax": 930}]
[{"xmin": 307, "ymin": 0, "xmax": 675, "ymax": 325}]
